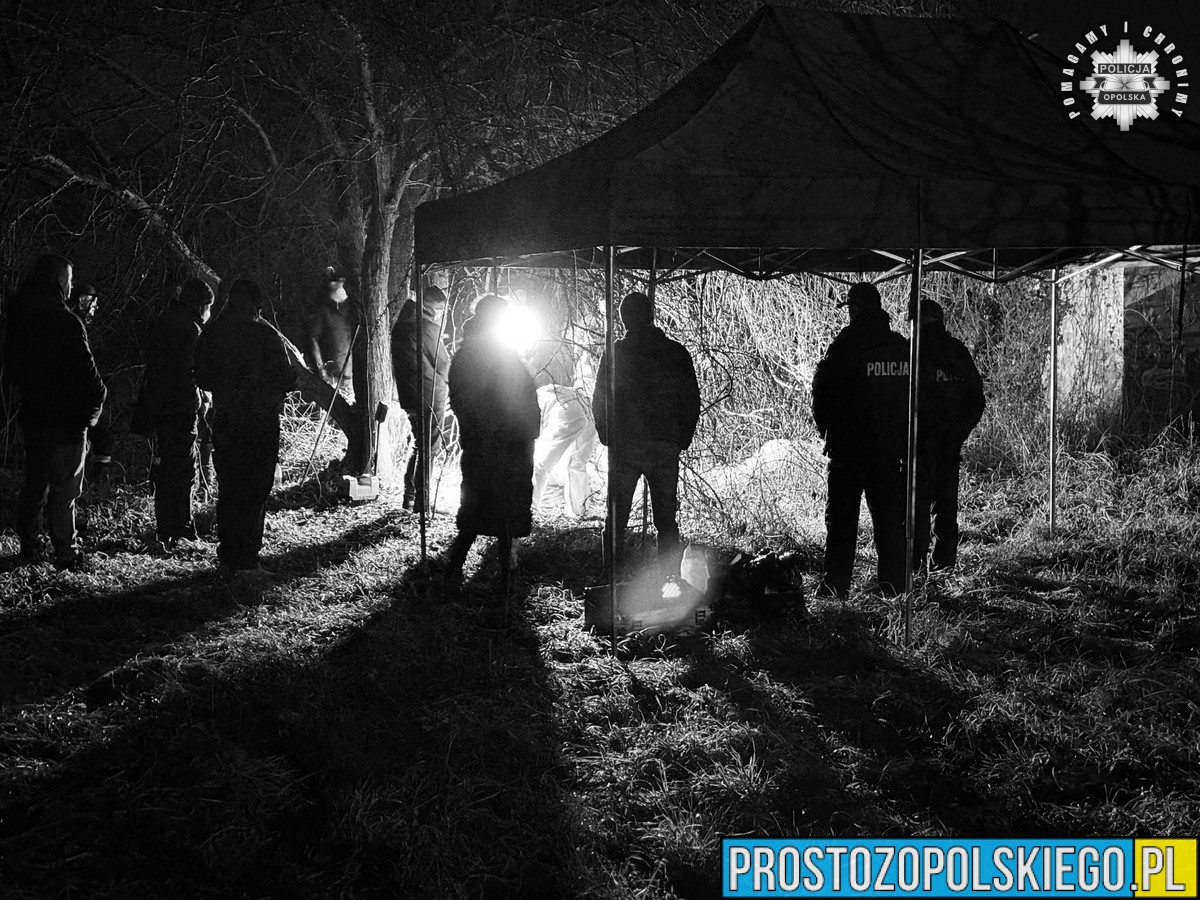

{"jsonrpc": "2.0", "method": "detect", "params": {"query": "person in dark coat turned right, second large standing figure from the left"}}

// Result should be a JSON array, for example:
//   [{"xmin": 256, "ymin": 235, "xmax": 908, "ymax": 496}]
[{"xmin": 137, "ymin": 278, "xmax": 212, "ymax": 551}]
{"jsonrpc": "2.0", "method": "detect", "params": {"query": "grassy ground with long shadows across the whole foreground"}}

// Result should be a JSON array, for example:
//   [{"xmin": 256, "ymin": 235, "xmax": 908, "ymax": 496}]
[{"xmin": 0, "ymin": 446, "xmax": 1200, "ymax": 898}]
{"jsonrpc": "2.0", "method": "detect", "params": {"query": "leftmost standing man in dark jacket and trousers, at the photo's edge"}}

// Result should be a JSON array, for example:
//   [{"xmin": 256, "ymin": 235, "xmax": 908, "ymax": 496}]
[{"xmin": 5, "ymin": 254, "xmax": 108, "ymax": 570}]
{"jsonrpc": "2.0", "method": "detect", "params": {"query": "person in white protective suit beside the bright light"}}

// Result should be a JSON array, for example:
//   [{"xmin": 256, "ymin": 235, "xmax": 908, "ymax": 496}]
[{"xmin": 526, "ymin": 328, "xmax": 599, "ymax": 518}]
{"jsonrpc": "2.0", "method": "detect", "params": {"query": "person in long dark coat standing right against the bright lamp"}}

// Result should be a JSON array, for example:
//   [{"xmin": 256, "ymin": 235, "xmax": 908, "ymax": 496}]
[{"xmin": 446, "ymin": 294, "xmax": 541, "ymax": 590}]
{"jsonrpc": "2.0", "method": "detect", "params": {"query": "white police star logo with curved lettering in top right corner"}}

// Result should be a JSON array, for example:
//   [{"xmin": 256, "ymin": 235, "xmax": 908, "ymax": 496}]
[{"xmin": 1060, "ymin": 22, "xmax": 1188, "ymax": 131}]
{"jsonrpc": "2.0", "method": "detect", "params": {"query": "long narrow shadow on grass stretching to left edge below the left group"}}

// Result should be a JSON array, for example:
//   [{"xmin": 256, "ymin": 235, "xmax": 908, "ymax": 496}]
[{"xmin": 0, "ymin": 512, "xmax": 403, "ymax": 706}]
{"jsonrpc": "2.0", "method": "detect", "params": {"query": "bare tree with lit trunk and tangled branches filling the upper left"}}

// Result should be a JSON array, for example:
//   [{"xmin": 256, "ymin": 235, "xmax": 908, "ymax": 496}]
[{"xmin": 0, "ymin": 0, "xmax": 743, "ymax": 476}]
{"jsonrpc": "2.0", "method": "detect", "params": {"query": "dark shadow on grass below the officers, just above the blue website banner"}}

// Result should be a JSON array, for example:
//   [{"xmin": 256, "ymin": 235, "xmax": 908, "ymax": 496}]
[{"xmin": 734, "ymin": 613, "xmax": 1016, "ymax": 835}]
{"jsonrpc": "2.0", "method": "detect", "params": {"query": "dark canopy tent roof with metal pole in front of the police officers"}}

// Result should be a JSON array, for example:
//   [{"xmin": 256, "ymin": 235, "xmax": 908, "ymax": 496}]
[{"xmin": 415, "ymin": 6, "xmax": 1200, "ymax": 643}]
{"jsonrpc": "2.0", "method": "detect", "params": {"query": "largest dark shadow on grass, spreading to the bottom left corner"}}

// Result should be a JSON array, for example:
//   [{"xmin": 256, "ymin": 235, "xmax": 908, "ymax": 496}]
[{"xmin": 0, "ymin": 561, "xmax": 577, "ymax": 896}]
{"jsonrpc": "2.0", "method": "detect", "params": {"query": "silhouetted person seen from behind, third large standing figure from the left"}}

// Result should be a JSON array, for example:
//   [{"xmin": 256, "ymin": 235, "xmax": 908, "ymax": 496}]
[{"xmin": 196, "ymin": 280, "xmax": 296, "ymax": 571}]
